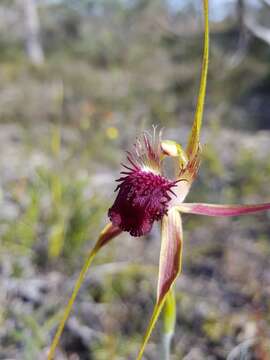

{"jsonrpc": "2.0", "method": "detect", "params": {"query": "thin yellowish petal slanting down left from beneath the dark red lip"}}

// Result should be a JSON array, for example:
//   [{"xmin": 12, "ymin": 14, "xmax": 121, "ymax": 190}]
[{"xmin": 47, "ymin": 223, "xmax": 122, "ymax": 360}]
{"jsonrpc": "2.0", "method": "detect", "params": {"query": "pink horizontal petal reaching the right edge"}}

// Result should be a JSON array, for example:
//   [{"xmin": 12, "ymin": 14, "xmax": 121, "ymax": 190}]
[{"xmin": 175, "ymin": 203, "xmax": 270, "ymax": 216}]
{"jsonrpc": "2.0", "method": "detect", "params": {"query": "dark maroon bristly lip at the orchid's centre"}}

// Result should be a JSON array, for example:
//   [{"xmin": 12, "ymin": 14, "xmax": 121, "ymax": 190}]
[{"xmin": 108, "ymin": 167, "xmax": 176, "ymax": 236}]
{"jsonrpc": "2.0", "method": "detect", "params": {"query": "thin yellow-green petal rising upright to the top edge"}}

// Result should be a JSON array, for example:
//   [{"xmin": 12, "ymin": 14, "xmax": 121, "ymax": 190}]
[{"xmin": 187, "ymin": 0, "xmax": 209, "ymax": 158}]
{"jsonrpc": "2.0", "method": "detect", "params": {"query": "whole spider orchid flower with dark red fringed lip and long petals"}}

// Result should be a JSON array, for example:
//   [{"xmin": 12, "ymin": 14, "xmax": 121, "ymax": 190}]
[{"xmin": 48, "ymin": 0, "xmax": 270, "ymax": 360}]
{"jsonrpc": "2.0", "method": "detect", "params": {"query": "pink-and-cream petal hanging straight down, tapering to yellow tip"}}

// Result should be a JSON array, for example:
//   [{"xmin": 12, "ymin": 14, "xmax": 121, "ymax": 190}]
[{"xmin": 137, "ymin": 208, "xmax": 183, "ymax": 360}]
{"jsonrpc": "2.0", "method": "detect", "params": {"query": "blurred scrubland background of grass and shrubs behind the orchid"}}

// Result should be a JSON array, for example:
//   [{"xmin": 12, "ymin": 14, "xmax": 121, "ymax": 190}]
[{"xmin": 0, "ymin": 0, "xmax": 270, "ymax": 360}]
